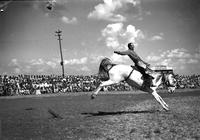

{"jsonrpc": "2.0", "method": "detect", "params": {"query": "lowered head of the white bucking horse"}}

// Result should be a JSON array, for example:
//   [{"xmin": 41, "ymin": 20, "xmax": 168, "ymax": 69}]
[{"xmin": 164, "ymin": 73, "xmax": 177, "ymax": 93}]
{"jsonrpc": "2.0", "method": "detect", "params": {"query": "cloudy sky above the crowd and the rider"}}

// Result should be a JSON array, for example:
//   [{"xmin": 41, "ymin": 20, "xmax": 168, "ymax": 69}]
[{"xmin": 0, "ymin": 0, "xmax": 200, "ymax": 75}]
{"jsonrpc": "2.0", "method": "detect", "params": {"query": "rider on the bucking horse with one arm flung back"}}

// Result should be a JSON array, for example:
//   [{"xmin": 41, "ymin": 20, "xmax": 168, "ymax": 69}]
[{"xmin": 114, "ymin": 43, "xmax": 154, "ymax": 86}]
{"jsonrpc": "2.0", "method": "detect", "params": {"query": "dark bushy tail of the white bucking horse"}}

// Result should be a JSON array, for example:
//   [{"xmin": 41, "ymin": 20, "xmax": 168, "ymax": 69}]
[{"xmin": 98, "ymin": 58, "xmax": 112, "ymax": 81}]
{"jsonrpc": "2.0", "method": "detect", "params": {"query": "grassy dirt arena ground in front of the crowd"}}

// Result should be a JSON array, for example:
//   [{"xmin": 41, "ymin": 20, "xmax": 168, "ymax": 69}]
[{"xmin": 0, "ymin": 90, "xmax": 200, "ymax": 140}]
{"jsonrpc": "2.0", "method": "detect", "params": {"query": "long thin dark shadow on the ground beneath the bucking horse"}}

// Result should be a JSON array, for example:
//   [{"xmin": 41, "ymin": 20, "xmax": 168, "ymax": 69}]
[{"xmin": 81, "ymin": 110, "xmax": 160, "ymax": 117}]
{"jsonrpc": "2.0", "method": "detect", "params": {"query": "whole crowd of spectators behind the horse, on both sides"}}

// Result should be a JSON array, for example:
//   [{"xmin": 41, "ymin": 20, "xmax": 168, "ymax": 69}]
[{"xmin": 0, "ymin": 75, "xmax": 200, "ymax": 96}]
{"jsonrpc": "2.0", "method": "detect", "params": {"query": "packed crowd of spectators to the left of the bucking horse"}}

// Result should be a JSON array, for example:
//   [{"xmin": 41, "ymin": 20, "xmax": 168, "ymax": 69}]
[{"xmin": 0, "ymin": 75, "xmax": 99, "ymax": 96}]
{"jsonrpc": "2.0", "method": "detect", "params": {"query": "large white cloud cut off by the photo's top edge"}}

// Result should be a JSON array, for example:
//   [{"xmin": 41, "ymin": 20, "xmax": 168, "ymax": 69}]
[{"xmin": 88, "ymin": 0, "xmax": 137, "ymax": 22}]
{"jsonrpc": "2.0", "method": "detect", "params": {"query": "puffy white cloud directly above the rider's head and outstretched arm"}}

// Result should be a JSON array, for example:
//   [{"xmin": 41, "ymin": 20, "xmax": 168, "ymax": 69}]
[{"xmin": 101, "ymin": 23, "xmax": 144, "ymax": 49}]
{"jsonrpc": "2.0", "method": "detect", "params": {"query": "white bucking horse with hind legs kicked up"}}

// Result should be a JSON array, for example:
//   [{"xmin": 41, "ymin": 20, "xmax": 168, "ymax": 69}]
[{"xmin": 91, "ymin": 58, "xmax": 176, "ymax": 110}]
